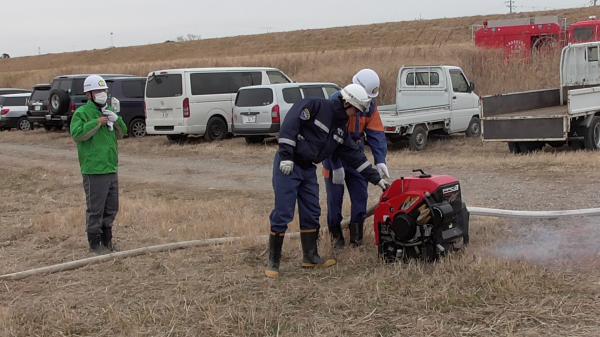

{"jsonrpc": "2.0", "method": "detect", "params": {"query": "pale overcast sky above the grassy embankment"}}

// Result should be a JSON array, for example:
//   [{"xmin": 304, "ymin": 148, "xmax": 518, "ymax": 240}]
[{"xmin": 0, "ymin": 0, "xmax": 589, "ymax": 57}]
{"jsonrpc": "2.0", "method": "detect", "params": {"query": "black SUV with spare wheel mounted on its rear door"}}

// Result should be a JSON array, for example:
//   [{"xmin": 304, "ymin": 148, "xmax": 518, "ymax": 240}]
[{"xmin": 44, "ymin": 74, "xmax": 133, "ymax": 128}]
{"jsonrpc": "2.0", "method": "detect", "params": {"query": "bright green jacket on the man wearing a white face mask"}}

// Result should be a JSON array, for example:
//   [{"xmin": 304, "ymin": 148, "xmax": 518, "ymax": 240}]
[{"xmin": 71, "ymin": 101, "xmax": 127, "ymax": 174}]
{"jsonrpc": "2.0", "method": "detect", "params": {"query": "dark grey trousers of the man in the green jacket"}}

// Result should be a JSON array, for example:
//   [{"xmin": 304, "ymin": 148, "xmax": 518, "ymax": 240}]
[{"xmin": 83, "ymin": 173, "xmax": 119, "ymax": 234}]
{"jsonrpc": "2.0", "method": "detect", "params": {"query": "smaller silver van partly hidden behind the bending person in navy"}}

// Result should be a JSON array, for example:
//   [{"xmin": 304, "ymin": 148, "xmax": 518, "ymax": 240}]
[{"xmin": 232, "ymin": 83, "xmax": 340, "ymax": 144}]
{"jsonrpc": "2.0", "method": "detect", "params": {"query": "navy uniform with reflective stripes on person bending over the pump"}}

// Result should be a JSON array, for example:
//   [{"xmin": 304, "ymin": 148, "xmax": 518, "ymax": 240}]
[{"xmin": 270, "ymin": 99, "xmax": 381, "ymax": 233}]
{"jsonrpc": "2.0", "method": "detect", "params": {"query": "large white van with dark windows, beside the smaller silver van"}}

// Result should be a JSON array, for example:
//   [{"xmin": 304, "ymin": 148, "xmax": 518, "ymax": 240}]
[{"xmin": 145, "ymin": 67, "xmax": 292, "ymax": 141}]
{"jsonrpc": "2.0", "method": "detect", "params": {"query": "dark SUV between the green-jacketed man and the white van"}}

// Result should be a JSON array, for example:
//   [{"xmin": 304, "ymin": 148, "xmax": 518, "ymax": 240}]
[{"xmin": 106, "ymin": 77, "xmax": 146, "ymax": 138}]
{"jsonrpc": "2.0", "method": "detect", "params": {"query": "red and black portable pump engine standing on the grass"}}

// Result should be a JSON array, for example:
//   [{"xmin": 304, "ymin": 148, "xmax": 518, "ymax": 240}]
[{"xmin": 374, "ymin": 170, "xmax": 469, "ymax": 262}]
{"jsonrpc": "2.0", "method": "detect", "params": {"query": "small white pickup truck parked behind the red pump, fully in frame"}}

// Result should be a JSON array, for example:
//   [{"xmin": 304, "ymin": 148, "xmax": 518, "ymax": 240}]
[{"xmin": 379, "ymin": 66, "xmax": 480, "ymax": 151}]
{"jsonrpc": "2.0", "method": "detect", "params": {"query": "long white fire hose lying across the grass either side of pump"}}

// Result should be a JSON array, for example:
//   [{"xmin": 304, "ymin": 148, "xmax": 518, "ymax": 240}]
[{"xmin": 0, "ymin": 206, "xmax": 600, "ymax": 280}]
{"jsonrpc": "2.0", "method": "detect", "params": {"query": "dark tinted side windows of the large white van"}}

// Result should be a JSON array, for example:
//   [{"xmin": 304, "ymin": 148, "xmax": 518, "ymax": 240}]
[{"xmin": 190, "ymin": 72, "xmax": 262, "ymax": 95}]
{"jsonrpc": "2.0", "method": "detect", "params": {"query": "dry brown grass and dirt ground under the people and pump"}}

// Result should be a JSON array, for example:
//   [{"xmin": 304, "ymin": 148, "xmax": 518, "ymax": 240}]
[{"xmin": 0, "ymin": 130, "xmax": 600, "ymax": 336}]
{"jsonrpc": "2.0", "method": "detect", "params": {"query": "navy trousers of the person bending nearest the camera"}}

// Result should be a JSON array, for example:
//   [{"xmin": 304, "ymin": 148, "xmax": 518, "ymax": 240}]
[{"xmin": 270, "ymin": 154, "xmax": 321, "ymax": 233}]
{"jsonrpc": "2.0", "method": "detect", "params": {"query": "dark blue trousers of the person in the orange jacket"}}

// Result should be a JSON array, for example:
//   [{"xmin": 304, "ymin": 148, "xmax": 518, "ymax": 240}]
[{"xmin": 325, "ymin": 164, "xmax": 369, "ymax": 230}]
